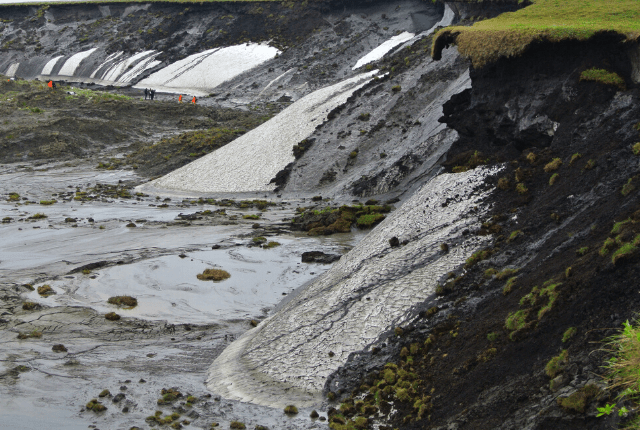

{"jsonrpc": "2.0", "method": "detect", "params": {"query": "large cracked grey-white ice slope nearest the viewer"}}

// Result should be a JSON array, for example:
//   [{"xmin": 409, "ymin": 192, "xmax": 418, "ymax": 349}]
[{"xmin": 207, "ymin": 168, "xmax": 498, "ymax": 407}]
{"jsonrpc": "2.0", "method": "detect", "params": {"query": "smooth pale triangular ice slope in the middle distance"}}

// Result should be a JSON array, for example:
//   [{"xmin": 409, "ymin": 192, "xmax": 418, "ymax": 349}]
[{"xmin": 139, "ymin": 70, "xmax": 377, "ymax": 193}]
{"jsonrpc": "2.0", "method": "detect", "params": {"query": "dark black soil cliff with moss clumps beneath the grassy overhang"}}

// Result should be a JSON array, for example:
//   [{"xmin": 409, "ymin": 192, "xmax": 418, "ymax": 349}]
[{"xmin": 327, "ymin": 37, "xmax": 640, "ymax": 429}]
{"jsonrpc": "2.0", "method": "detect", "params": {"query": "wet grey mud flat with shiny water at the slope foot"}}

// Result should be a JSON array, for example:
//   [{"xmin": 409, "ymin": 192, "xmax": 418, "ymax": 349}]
[{"xmin": 0, "ymin": 156, "xmax": 361, "ymax": 429}]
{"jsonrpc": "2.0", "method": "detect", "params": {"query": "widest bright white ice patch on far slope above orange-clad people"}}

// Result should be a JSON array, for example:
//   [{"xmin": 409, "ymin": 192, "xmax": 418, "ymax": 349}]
[{"xmin": 134, "ymin": 43, "xmax": 280, "ymax": 96}]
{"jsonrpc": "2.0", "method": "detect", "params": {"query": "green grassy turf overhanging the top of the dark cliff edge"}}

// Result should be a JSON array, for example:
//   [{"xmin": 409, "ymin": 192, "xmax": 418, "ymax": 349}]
[{"xmin": 432, "ymin": 0, "xmax": 640, "ymax": 68}]
